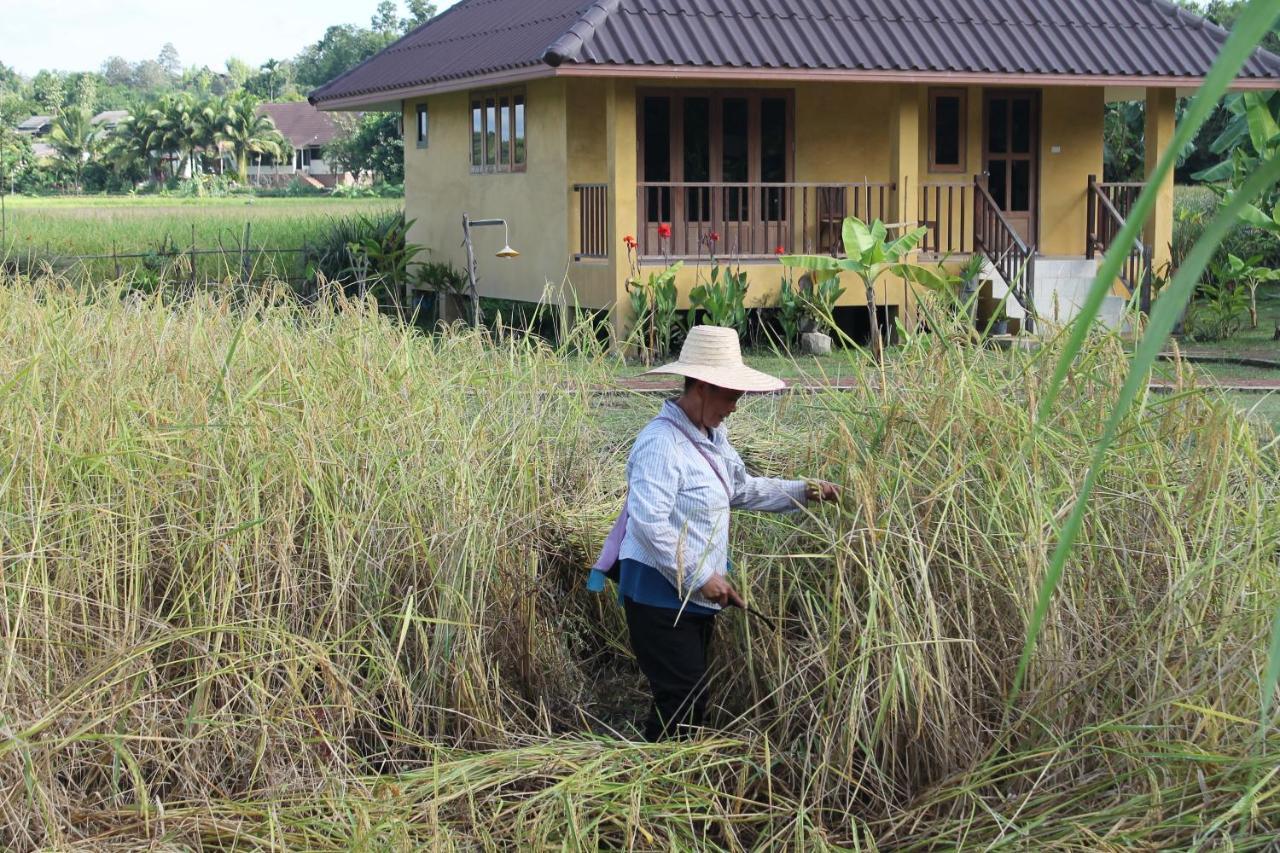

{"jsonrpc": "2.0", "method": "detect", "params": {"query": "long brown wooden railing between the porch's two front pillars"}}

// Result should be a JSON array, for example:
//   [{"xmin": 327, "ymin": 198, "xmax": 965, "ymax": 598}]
[{"xmin": 636, "ymin": 182, "xmax": 895, "ymax": 259}]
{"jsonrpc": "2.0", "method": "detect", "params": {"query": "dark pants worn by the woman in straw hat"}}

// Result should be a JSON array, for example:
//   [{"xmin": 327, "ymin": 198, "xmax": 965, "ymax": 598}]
[{"xmin": 623, "ymin": 598, "xmax": 716, "ymax": 740}]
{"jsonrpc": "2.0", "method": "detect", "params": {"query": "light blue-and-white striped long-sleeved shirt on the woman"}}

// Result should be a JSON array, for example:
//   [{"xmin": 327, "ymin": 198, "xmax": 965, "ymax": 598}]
[{"xmin": 620, "ymin": 401, "xmax": 805, "ymax": 610}]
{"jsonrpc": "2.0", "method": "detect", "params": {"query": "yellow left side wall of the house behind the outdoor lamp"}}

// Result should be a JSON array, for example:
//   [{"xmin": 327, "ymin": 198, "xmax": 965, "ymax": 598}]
[{"xmin": 403, "ymin": 79, "xmax": 570, "ymax": 301}]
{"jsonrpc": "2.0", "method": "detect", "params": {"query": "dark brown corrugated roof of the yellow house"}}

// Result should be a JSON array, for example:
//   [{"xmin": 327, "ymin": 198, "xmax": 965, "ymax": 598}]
[{"xmin": 311, "ymin": 0, "xmax": 1280, "ymax": 105}]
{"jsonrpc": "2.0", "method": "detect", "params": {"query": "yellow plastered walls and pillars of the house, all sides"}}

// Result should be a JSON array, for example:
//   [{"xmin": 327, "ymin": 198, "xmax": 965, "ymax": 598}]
[{"xmin": 404, "ymin": 78, "xmax": 1121, "ymax": 324}]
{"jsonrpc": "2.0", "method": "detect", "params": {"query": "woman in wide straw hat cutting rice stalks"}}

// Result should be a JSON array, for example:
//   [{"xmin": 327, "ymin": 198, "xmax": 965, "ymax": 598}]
[{"xmin": 590, "ymin": 325, "xmax": 840, "ymax": 740}]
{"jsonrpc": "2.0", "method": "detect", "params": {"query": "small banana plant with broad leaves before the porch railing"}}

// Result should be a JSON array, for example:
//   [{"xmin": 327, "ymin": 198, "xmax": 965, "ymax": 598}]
[{"xmin": 782, "ymin": 216, "xmax": 945, "ymax": 361}]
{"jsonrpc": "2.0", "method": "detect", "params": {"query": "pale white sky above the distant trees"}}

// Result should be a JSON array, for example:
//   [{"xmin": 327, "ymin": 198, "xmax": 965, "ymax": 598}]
[{"xmin": 0, "ymin": 0, "xmax": 454, "ymax": 77}]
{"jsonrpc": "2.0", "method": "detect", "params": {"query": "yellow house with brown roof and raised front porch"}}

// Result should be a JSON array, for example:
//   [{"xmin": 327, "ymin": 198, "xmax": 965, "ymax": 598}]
[{"xmin": 311, "ymin": 0, "xmax": 1280, "ymax": 330}]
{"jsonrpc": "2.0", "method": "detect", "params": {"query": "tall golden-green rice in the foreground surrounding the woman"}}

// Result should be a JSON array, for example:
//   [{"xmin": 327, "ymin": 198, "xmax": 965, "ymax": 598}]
[{"xmin": 0, "ymin": 272, "xmax": 1280, "ymax": 850}]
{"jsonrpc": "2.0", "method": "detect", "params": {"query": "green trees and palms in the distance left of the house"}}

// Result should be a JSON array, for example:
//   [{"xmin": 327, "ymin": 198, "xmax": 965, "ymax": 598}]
[{"xmin": 0, "ymin": 0, "xmax": 436, "ymax": 192}]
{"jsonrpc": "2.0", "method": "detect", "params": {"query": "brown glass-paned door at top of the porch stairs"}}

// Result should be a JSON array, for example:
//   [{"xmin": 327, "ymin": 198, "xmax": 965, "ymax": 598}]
[{"xmin": 983, "ymin": 91, "xmax": 1039, "ymax": 246}]
